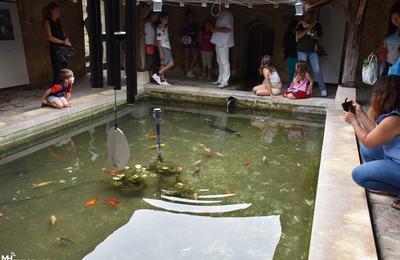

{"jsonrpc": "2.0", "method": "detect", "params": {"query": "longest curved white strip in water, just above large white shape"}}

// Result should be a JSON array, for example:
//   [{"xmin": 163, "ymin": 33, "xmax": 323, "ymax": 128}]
[{"xmin": 143, "ymin": 199, "xmax": 251, "ymax": 213}]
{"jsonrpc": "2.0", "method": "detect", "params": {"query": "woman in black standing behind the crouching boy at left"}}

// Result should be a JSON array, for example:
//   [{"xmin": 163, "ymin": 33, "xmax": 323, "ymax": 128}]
[{"xmin": 42, "ymin": 2, "xmax": 71, "ymax": 83}]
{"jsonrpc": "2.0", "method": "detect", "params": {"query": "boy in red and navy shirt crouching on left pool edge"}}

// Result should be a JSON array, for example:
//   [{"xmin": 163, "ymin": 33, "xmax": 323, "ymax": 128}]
[{"xmin": 42, "ymin": 69, "xmax": 75, "ymax": 108}]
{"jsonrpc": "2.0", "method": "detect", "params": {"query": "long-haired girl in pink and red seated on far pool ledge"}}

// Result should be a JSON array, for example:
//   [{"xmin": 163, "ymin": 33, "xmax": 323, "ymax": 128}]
[{"xmin": 283, "ymin": 61, "xmax": 313, "ymax": 99}]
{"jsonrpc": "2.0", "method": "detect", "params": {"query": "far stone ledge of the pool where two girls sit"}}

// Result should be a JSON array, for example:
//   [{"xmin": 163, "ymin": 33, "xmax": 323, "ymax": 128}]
[{"xmin": 144, "ymin": 84, "xmax": 335, "ymax": 115}]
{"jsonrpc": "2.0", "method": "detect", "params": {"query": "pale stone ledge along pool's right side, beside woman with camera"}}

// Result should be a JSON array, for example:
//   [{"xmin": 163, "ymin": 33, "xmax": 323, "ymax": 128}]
[{"xmin": 309, "ymin": 87, "xmax": 378, "ymax": 260}]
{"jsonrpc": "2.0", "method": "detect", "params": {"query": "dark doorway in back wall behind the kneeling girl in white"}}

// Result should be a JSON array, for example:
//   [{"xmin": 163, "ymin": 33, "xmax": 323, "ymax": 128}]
[{"xmin": 245, "ymin": 22, "xmax": 274, "ymax": 86}]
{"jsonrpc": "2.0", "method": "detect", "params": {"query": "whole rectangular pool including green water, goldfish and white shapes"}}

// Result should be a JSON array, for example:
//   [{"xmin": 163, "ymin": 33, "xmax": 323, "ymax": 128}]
[{"xmin": 0, "ymin": 100, "xmax": 325, "ymax": 259}]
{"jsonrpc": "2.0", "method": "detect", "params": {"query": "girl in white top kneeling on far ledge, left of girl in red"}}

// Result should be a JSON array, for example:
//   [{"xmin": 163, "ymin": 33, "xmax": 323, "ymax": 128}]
[{"xmin": 253, "ymin": 55, "xmax": 282, "ymax": 96}]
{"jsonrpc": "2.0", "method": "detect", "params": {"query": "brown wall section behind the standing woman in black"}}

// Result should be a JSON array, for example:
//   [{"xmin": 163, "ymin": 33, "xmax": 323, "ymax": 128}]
[{"xmin": 17, "ymin": 0, "xmax": 85, "ymax": 85}]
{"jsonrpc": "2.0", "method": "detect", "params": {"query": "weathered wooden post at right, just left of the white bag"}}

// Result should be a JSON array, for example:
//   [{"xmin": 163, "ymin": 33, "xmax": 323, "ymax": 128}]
[{"xmin": 342, "ymin": 0, "xmax": 367, "ymax": 87}]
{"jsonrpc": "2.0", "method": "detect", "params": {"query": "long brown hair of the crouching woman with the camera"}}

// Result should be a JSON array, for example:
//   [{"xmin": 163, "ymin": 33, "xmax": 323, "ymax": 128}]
[{"xmin": 369, "ymin": 75, "xmax": 400, "ymax": 120}]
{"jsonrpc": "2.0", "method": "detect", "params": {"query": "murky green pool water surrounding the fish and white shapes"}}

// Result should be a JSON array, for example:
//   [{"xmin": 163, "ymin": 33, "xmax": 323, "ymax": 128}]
[{"xmin": 0, "ymin": 100, "xmax": 324, "ymax": 259}]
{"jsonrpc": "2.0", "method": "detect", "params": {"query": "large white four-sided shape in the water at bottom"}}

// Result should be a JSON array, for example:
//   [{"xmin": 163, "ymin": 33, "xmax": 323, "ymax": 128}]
[{"xmin": 84, "ymin": 209, "xmax": 281, "ymax": 260}]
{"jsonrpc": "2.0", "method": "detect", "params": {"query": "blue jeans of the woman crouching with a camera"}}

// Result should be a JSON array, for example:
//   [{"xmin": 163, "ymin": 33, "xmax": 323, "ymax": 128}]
[{"xmin": 352, "ymin": 146, "xmax": 400, "ymax": 197}]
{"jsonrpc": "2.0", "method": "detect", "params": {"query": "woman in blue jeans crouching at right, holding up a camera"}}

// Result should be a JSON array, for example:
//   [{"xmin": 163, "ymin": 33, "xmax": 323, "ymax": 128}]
[{"xmin": 344, "ymin": 75, "xmax": 400, "ymax": 209}]
